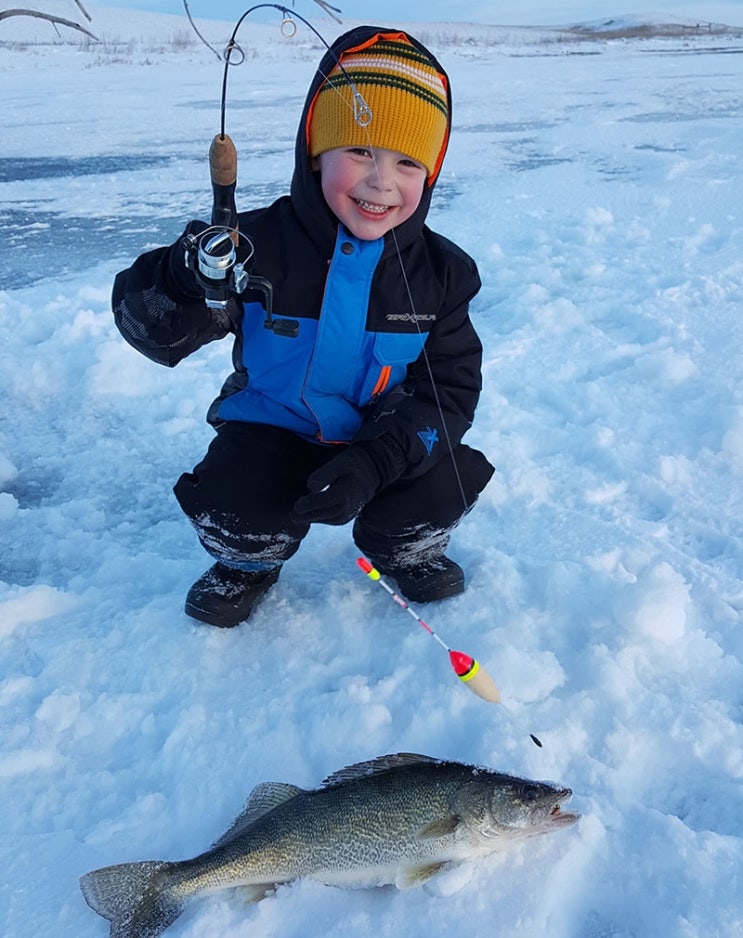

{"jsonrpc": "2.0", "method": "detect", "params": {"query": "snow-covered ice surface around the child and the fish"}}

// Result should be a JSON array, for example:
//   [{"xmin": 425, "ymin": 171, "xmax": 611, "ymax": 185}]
[{"xmin": 0, "ymin": 4, "xmax": 743, "ymax": 938}]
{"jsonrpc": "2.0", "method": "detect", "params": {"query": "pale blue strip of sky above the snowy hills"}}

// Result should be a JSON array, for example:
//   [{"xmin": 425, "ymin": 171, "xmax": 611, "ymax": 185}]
[{"xmin": 85, "ymin": 0, "xmax": 743, "ymax": 26}]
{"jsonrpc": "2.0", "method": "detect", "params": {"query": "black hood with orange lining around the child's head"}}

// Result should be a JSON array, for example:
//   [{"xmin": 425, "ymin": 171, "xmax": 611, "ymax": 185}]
[{"xmin": 291, "ymin": 26, "xmax": 451, "ymax": 257}]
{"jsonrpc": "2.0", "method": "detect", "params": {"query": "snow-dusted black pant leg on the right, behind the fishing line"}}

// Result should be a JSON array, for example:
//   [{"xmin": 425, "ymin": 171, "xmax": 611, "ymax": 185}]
[{"xmin": 353, "ymin": 443, "xmax": 494, "ymax": 570}]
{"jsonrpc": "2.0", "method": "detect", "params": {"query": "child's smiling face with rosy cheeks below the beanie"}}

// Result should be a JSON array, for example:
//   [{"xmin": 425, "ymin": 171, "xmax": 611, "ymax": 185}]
[{"xmin": 313, "ymin": 147, "xmax": 427, "ymax": 241}]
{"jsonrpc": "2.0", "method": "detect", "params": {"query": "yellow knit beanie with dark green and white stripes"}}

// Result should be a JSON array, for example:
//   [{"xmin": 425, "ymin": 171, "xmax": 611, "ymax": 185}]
[{"xmin": 307, "ymin": 33, "xmax": 449, "ymax": 184}]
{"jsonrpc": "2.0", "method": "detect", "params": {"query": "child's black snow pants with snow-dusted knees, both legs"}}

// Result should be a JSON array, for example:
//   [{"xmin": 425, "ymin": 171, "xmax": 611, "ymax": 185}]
[{"xmin": 174, "ymin": 421, "xmax": 493, "ymax": 570}]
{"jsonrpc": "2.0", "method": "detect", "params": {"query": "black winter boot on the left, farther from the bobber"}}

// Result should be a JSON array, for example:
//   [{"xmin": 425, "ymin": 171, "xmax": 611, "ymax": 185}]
[{"xmin": 185, "ymin": 562, "xmax": 281, "ymax": 629}]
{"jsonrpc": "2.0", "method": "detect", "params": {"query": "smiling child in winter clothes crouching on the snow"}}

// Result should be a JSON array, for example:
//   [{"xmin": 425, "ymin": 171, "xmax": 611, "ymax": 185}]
[{"xmin": 112, "ymin": 26, "xmax": 493, "ymax": 627}]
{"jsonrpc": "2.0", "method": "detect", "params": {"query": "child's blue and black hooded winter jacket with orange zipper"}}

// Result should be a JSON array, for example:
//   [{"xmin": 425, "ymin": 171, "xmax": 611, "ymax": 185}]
[{"xmin": 112, "ymin": 27, "xmax": 482, "ymax": 477}]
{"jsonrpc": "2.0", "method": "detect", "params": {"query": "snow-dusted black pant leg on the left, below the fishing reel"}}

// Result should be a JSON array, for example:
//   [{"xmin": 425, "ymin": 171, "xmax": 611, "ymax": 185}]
[{"xmin": 174, "ymin": 421, "xmax": 331, "ymax": 570}]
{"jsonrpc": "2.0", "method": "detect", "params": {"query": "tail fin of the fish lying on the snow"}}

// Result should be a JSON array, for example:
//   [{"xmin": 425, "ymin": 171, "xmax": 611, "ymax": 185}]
[{"xmin": 80, "ymin": 860, "xmax": 182, "ymax": 938}]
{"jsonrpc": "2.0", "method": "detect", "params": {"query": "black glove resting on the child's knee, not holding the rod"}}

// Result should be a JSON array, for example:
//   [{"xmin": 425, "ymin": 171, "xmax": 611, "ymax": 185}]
[{"xmin": 292, "ymin": 436, "xmax": 405, "ymax": 524}]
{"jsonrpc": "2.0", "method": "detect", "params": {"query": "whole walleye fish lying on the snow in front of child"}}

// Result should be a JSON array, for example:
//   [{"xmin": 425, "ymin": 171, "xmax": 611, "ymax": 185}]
[{"xmin": 80, "ymin": 753, "xmax": 580, "ymax": 938}]
